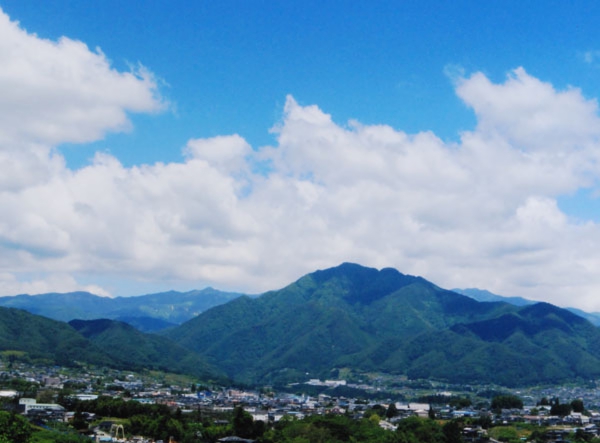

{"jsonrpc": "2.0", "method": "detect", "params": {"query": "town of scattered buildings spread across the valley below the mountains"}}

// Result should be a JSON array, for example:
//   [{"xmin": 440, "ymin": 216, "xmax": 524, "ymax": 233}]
[{"xmin": 0, "ymin": 362, "xmax": 600, "ymax": 443}]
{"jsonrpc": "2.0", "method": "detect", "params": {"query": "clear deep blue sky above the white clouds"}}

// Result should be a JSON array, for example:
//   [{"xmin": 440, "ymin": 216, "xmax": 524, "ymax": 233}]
[{"xmin": 8, "ymin": 1, "xmax": 600, "ymax": 166}]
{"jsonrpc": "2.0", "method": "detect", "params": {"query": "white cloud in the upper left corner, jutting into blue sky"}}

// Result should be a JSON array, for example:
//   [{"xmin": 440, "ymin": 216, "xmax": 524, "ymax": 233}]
[{"xmin": 0, "ymin": 11, "xmax": 164, "ymax": 149}]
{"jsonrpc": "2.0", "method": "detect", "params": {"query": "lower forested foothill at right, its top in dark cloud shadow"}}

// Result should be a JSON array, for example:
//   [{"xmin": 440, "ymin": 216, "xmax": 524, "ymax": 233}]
[{"xmin": 405, "ymin": 303, "xmax": 600, "ymax": 386}]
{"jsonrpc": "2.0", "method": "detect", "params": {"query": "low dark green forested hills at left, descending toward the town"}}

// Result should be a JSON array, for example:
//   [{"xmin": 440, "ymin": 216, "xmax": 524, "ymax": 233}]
[{"xmin": 0, "ymin": 307, "xmax": 224, "ymax": 380}]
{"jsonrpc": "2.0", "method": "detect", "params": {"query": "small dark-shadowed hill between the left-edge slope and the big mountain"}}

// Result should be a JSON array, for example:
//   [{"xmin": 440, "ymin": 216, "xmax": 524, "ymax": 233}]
[{"xmin": 69, "ymin": 319, "xmax": 225, "ymax": 380}]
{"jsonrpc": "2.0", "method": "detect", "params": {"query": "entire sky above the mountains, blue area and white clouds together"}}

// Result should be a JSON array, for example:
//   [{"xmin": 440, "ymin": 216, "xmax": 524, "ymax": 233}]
[{"xmin": 0, "ymin": 0, "xmax": 600, "ymax": 310}]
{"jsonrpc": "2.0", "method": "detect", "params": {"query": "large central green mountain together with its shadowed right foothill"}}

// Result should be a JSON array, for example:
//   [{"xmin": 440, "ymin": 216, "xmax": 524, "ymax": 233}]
[{"xmin": 165, "ymin": 263, "xmax": 600, "ymax": 385}]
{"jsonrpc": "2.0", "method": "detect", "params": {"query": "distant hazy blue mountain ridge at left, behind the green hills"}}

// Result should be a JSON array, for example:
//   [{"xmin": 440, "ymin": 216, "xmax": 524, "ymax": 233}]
[{"xmin": 0, "ymin": 288, "xmax": 241, "ymax": 332}]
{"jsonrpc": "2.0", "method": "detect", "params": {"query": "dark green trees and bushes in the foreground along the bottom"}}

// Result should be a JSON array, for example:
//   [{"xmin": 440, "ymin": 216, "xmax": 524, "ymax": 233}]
[{"xmin": 0, "ymin": 396, "xmax": 600, "ymax": 443}]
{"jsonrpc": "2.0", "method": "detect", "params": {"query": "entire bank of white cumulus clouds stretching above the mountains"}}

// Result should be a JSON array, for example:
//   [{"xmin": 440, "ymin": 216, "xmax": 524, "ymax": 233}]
[{"xmin": 0, "ymin": 6, "xmax": 600, "ymax": 309}]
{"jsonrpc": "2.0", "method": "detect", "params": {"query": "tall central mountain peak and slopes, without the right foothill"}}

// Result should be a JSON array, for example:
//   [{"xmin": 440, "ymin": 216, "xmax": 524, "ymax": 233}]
[{"xmin": 165, "ymin": 263, "xmax": 516, "ymax": 382}]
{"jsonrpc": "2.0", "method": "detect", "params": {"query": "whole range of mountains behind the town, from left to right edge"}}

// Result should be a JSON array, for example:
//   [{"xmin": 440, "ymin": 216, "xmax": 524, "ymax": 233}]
[{"xmin": 0, "ymin": 263, "xmax": 600, "ymax": 386}]
